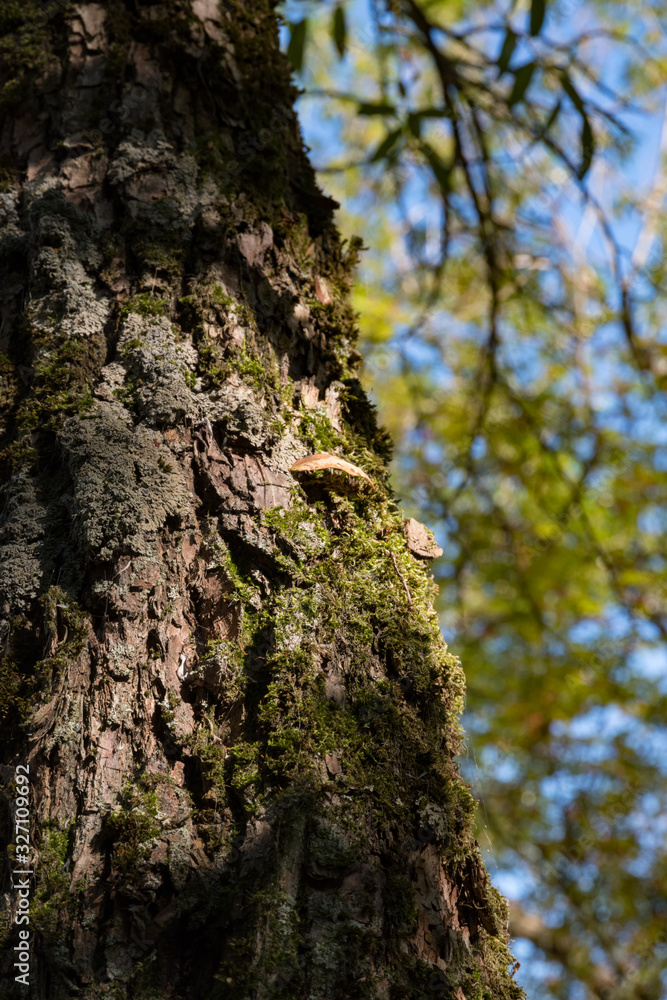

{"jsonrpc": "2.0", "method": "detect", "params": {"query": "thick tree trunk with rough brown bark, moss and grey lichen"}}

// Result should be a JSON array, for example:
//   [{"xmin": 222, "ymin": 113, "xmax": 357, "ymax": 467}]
[{"xmin": 0, "ymin": 0, "xmax": 521, "ymax": 1000}]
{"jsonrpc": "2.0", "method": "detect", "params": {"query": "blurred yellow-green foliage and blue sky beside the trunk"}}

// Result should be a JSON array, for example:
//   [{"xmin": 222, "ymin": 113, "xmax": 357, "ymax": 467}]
[{"xmin": 285, "ymin": 0, "xmax": 667, "ymax": 1000}]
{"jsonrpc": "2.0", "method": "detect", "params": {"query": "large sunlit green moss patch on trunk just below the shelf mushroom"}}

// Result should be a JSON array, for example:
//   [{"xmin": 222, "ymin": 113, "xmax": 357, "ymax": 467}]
[{"xmin": 198, "ymin": 493, "xmax": 472, "ymax": 884}]
